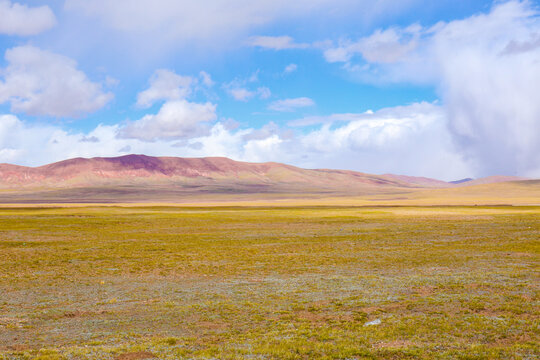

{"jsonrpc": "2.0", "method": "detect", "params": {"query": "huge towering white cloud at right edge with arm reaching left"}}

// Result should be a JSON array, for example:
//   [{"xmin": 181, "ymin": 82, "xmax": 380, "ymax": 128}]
[{"xmin": 325, "ymin": 1, "xmax": 540, "ymax": 175}]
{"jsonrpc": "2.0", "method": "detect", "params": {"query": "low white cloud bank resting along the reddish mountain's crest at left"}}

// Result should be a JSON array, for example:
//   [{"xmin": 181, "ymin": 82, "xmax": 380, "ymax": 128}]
[{"xmin": 0, "ymin": 114, "xmax": 274, "ymax": 166}]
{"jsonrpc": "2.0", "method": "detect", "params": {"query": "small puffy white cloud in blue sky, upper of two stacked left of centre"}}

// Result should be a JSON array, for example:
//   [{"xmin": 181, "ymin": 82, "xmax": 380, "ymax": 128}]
[{"xmin": 137, "ymin": 69, "xmax": 195, "ymax": 108}]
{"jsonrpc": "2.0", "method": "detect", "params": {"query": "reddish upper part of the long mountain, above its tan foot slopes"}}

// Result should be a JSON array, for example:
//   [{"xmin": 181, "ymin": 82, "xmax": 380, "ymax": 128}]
[{"xmin": 0, "ymin": 155, "xmax": 407, "ymax": 188}]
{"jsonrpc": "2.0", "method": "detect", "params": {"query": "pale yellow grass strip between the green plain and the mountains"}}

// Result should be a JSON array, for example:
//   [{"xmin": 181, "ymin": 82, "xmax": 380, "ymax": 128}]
[{"xmin": 0, "ymin": 180, "xmax": 540, "ymax": 207}]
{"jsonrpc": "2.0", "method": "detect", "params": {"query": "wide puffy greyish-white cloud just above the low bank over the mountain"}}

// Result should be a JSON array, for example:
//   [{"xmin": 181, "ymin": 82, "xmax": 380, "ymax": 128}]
[{"xmin": 119, "ymin": 100, "xmax": 216, "ymax": 141}]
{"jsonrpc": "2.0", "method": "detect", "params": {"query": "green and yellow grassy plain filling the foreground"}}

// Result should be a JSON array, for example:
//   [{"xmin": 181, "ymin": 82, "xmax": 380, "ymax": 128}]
[{"xmin": 0, "ymin": 206, "xmax": 540, "ymax": 360}]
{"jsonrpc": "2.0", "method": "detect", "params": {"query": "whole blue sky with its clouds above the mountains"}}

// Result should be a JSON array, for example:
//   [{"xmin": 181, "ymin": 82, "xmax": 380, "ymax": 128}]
[{"xmin": 0, "ymin": 0, "xmax": 540, "ymax": 180}]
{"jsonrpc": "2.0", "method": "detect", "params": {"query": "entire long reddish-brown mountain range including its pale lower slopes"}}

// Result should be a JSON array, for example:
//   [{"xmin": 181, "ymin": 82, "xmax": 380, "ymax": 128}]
[{"xmin": 0, "ymin": 155, "xmax": 532, "ymax": 202}]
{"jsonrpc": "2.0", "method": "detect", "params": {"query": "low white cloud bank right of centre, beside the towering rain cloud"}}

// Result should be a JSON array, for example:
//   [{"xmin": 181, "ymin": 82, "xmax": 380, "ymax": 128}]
[{"xmin": 291, "ymin": 103, "xmax": 470, "ymax": 180}]
